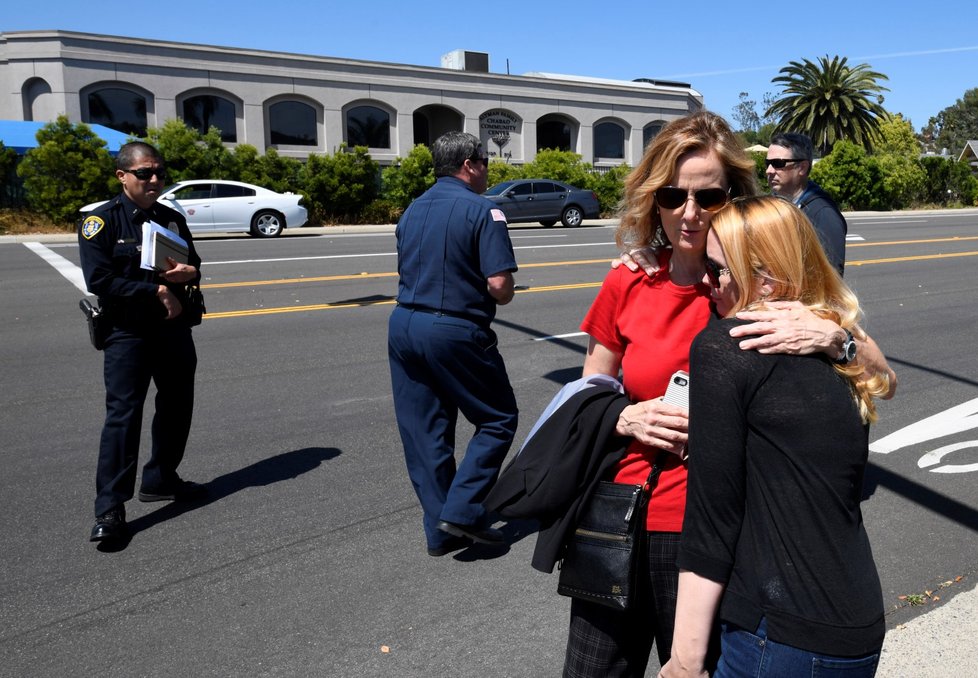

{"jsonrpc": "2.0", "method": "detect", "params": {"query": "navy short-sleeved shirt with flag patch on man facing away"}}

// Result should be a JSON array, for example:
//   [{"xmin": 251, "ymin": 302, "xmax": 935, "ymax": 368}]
[{"xmin": 396, "ymin": 177, "xmax": 517, "ymax": 323}]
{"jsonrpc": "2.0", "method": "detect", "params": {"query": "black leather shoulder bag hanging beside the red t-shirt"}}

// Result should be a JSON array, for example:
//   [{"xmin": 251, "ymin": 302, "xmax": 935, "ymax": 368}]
[{"xmin": 557, "ymin": 453, "xmax": 668, "ymax": 610}]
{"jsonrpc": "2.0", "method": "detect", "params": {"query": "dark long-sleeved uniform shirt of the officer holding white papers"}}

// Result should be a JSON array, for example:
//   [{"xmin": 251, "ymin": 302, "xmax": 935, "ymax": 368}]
[{"xmin": 78, "ymin": 193, "xmax": 200, "ymax": 326}]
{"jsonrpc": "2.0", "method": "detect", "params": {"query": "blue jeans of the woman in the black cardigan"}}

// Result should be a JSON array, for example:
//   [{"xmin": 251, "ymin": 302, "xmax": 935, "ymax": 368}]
[{"xmin": 713, "ymin": 619, "xmax": 880, "ymax": 678}]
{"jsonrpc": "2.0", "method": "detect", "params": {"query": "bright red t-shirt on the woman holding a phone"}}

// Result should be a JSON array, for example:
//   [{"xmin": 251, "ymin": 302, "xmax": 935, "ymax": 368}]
[{"xmin": 581, "ymin": 253, "xmax": 710, "ymax": 532}]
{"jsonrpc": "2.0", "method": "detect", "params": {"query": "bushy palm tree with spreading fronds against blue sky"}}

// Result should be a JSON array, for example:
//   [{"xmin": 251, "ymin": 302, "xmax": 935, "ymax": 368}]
[{"xmin": 764, "ymin": 55, "xmax": 890, "ymax": 155}]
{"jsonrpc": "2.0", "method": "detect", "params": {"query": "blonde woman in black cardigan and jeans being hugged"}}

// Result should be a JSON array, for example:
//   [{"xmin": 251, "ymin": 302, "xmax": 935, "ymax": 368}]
[{"xmin": 660, "ymin": 197, "xmax": 890, "ymax": 678}]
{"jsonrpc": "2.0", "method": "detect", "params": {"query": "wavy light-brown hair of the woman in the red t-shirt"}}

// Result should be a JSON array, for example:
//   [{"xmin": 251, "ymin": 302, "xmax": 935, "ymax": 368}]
[{"xmin": 615, "ymin": 111, "xmax": 757, "ymax": 251}]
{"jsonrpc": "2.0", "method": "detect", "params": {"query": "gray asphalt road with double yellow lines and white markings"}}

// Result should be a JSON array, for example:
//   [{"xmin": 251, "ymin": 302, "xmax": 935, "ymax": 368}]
[{"xmin": 0, "ymin": 211, "xmax": 978, "ymax": 677}]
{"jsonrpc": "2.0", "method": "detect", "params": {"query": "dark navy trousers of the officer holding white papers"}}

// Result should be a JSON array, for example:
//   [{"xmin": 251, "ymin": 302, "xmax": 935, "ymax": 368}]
[{"xmin": 95, "ymin": 325, "xmax": 197, "ymax": 516}]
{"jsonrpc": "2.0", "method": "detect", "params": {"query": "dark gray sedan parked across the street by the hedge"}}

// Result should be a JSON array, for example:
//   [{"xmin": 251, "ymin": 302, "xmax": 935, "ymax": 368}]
[{"xmin": 483, "ymin": 179, "xmax": 601, "ymax": 227}]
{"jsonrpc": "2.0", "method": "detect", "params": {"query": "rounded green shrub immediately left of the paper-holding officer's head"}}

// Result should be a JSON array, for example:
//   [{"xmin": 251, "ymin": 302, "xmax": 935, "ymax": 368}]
[{"xmin": 17, "ymin": 115, "xmax": 118, "ymax": 223}]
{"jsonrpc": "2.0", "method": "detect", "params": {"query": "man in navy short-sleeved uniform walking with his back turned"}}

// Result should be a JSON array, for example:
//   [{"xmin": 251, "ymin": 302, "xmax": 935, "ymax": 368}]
[{"xmin": 388, "ymin": 132, "xmax": 517, "ymax": 556}]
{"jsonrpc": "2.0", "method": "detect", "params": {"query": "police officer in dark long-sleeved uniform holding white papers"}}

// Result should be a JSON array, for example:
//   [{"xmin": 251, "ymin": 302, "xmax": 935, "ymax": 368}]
[{"xmin": 78, "ymin": 142, "xmax": 206, "ymax": 542}]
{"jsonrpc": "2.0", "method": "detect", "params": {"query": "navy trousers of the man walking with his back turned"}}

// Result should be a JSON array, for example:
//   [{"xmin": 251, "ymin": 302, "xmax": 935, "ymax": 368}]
[{"xmin": 388, "ymin": 306, "xmax": 518, "ymax": 548}]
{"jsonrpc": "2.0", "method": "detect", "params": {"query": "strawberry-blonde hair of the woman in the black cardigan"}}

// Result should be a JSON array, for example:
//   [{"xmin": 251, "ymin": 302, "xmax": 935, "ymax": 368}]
[{"xmin": 711, "ymin": 196, "xmax": 889, "ymax": 423}]
